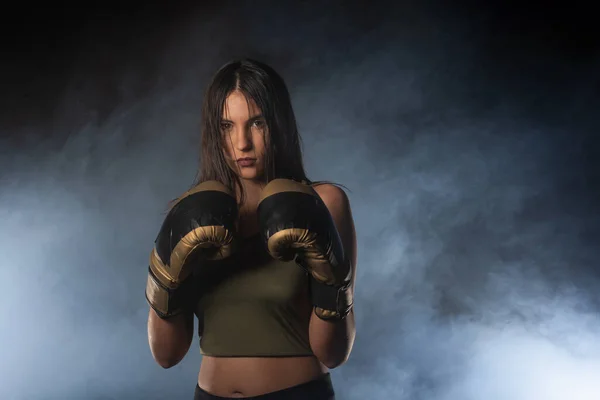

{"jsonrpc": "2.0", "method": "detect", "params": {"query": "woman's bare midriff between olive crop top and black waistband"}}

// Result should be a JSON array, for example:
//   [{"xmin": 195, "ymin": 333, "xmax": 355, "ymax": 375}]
[{"xmin": 198, "ymin": 356, "xmax": 327, "ymax": 398}]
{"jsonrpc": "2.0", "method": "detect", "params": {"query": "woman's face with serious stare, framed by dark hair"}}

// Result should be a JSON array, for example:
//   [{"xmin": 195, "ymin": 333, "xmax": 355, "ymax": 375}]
[{"xmin": 220, "ymin": 91, "xmax": 268, "ymax": 180}]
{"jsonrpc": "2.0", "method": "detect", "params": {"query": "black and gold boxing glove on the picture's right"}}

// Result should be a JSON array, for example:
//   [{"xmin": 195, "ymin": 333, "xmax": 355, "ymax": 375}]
[{"xmin": 258, "ymin": 179, "xmax": 353, "ymax": 320}]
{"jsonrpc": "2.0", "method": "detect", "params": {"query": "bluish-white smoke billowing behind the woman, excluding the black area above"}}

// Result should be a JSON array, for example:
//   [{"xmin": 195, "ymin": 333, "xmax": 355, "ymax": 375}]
[{"xmin": 0, "ymin": 1, "xmax": 600, "ymax": 400}]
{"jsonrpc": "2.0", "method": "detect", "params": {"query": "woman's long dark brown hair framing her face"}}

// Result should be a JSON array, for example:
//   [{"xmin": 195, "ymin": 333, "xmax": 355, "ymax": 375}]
[{"xmin": 194, "ymin": 59, "xmax": 317, "ymax": 203}]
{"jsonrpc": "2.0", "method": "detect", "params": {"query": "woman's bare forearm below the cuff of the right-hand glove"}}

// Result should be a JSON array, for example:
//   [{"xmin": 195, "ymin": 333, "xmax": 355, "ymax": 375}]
[{"xmin": 309, "ymin": 310, "xmax": 356, "ymax": 369}]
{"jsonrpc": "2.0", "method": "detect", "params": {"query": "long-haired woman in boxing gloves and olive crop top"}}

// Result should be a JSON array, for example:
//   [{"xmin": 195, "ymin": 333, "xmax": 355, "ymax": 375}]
[{"xmin": 146, "ymin": 60, "xmax": 356, "ymax": 400}]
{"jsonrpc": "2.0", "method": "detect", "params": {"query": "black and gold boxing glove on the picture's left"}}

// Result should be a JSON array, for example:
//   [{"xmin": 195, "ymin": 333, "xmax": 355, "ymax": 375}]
[{"xmin": 146, "ymin": 181, "xmax": 237, "ymax": 318}]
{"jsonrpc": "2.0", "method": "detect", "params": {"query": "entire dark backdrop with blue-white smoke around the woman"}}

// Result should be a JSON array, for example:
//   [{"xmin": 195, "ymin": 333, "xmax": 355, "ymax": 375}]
[{"xmin": 0, "ymin": 0, "xmax": 600, "ymax": 400}]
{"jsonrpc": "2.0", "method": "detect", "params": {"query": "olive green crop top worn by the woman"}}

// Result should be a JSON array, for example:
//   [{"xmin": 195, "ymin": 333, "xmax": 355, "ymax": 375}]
[{"xmin": 196, "ymin": 235, "xmax": 313, "ymax": 357}]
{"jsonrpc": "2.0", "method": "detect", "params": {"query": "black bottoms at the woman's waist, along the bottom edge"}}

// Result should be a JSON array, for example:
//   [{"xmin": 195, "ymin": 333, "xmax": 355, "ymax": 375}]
[{"xmin": 194, "ymin": 374, "xmax": 335, "ymax": 400}]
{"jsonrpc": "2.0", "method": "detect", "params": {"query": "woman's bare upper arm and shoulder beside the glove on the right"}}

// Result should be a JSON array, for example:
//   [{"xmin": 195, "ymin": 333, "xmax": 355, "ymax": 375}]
[{"xmin": 313, "ymin": 184, "xmax": 357, "ymax": 286}]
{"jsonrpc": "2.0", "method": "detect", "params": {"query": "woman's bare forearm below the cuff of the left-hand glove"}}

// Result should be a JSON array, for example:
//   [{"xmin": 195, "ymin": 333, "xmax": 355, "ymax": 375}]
[{"xmin": 148, "ymin": 308, "xmax": 194, "ymax": 368}]
